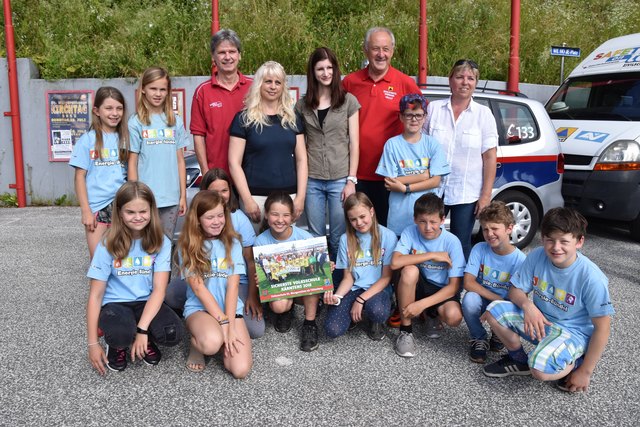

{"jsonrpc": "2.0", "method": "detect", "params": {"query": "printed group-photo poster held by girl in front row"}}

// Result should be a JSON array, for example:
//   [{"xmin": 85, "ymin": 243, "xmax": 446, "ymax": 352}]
[{"xmin": 253, "ymin": 237, "xmax": 333, "ymax": 302}]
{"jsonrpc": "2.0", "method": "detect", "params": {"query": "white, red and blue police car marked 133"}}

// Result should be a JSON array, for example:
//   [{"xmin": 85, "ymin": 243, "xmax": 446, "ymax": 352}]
[{"xmin": 422, "ymin": 86, "xmax": 564, "ymax": 248}]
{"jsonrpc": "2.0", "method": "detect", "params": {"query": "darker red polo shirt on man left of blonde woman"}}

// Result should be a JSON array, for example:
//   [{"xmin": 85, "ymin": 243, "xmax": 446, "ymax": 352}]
[{"xmin": 189, "ymin": 73, "xmax": 251, "ymax": 173}]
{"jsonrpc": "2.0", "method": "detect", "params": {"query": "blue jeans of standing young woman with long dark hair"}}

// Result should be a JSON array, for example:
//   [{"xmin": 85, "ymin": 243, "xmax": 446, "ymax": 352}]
[{"xmin": 304, "ymin": 178, "xmax": 347, "ymax": 256}]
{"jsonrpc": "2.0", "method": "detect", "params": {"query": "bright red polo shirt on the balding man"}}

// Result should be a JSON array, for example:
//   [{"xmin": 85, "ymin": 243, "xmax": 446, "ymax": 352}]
[{"xmin": 342, "ymin": 67, "xmax": 420, "ymax": 181}]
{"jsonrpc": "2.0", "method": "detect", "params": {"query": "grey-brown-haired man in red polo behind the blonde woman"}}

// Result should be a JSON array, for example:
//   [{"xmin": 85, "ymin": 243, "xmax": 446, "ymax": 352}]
[{"xmin": 190, "ymin": 30, "xmax": 251, "ymax": 175}]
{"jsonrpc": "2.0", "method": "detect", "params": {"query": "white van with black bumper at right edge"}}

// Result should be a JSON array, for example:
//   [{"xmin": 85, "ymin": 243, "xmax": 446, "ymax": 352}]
[{"xmin": 546, "ymin": 33, "xmax": 640, "ymax": 240}]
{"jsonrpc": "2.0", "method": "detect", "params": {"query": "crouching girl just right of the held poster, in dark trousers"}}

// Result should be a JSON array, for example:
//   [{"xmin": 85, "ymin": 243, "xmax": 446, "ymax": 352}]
[{"xmin": 324, "ymin": 192, "xmax": 397, "ymax": 341}]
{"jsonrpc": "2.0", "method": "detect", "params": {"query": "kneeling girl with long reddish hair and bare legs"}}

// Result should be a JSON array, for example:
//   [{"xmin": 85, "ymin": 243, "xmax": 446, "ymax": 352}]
[{"xmin": 178, "ymin": 190, "xmax": 253, "ymax": 378}]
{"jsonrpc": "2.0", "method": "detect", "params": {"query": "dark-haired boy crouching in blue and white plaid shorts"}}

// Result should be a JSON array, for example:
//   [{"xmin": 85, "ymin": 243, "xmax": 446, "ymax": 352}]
[{"xmin": 482, "ymin": 208, "xmax": 614, "ymax": 392}]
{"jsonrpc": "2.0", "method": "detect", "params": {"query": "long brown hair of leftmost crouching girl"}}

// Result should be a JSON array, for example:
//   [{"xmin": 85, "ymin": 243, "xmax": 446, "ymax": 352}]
[{"xmin": 104, "ymin": 181, "xmax": 164, "ymax": 259}]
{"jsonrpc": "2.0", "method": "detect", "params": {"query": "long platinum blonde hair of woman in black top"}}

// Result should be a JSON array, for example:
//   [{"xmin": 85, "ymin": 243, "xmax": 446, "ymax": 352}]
[{"xmin": 242, "ymin": 61, "xmax": 298, "ymax": 133}]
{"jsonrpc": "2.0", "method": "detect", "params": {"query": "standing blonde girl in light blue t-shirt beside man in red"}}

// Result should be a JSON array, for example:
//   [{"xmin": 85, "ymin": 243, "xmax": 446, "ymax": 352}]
[{"xmin": 129, "ymin": 67, "xmax": 188, "ymax": 239}]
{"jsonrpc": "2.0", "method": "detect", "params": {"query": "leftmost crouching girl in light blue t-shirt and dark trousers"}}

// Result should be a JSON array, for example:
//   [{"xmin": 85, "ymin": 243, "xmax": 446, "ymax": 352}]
[{"xmin": 87, "ymin": 182, "xmax": 184, "ymax": 375}]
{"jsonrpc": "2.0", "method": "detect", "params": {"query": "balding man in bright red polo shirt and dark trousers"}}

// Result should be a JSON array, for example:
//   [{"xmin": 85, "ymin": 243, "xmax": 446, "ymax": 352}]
[{"xmin": 343, "ymin": 27, "xmax": 420, "ymax": 225}]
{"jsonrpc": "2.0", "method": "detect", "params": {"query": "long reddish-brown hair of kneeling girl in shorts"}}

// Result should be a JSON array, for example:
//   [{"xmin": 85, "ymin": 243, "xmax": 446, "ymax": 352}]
[{"xmin": 178, "ymin": 190, "xmax": 239, "ymax": 277}]
